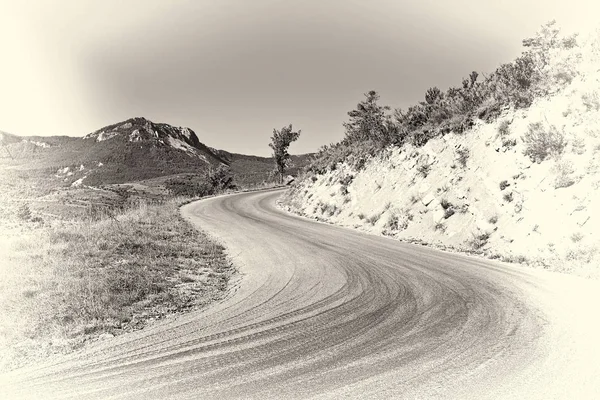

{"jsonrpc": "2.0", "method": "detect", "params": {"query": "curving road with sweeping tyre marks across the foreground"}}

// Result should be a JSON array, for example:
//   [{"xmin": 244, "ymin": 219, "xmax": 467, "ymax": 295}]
[{"xmin": 0, "ymin": 191, "xmax": 600, "ymax": 400}]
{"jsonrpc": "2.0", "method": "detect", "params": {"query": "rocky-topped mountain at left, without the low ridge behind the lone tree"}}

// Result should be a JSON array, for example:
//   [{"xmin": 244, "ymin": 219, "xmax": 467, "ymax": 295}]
[{"xmin": 3, "ymin": 118, "xmax": 227, "ymax": 186}]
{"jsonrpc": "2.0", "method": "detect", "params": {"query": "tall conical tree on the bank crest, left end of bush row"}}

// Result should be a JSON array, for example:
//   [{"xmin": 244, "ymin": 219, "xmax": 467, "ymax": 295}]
[{"xmin": 344, "ymin": 90, "xmax": 392, "ymax": 146}]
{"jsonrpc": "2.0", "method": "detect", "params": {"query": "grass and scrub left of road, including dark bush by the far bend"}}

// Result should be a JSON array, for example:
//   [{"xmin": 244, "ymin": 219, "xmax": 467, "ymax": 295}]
[{"xmin": 0, "ymin": 159, "xmax": 240, "ymax": 370}]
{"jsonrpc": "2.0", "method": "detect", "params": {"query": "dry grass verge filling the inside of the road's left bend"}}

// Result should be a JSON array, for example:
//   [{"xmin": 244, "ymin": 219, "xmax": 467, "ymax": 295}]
[{"xmin": 0, "ymin": 200, "xmax": 233, "ymax": 369}]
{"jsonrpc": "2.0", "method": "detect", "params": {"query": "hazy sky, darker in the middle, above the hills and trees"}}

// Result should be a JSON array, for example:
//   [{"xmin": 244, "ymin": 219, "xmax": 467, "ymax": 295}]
[{"xmin": 0, "ymin": 0, "xmax": 600, "ymax": 156}]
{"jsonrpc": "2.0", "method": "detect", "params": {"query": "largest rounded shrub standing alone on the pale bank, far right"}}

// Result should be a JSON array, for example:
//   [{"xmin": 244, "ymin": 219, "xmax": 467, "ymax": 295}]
[{"xmin": 523, "ymin": 122, "xmax": 566, "ymax": 163}]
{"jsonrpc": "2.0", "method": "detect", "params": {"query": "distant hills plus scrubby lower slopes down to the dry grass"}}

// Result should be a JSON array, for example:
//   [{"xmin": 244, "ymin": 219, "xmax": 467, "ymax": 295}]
[{"xmin": 0, "ymin": 118, "xmax": 310, "ymax": 218}]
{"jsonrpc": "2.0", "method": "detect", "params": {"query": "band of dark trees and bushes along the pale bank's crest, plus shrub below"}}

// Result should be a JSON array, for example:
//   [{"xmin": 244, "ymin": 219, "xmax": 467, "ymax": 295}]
[{"xmin": 307, "ymin": 21, "xmax": 580, "ymax": 174}]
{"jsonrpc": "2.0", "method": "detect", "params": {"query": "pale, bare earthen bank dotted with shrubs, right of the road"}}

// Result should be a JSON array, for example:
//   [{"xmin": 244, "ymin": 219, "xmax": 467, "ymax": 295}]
[{"xmin": 283, "ymin": 21, "xmax": 600, "ymax": 278}]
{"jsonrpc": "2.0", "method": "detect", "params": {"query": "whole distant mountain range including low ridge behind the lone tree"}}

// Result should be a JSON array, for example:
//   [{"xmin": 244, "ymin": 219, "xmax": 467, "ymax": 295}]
[{"xmin": 0, "ymin": 117, "xmax": 309, "ymax": 191}]
